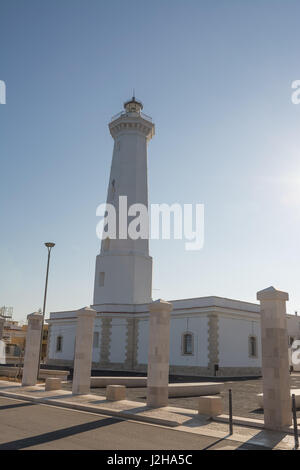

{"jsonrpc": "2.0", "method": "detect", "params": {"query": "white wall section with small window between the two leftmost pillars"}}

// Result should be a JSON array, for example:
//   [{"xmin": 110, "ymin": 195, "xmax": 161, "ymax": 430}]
[{"xmin": 48, "ymin": 322, "xmax": 76, "ymax": 361}]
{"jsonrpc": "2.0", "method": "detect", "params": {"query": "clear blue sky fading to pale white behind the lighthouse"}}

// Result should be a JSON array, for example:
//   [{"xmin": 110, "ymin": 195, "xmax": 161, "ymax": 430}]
[{"xmin": 0, "ymin": 0, "xmax": 300, "ymax": 320}]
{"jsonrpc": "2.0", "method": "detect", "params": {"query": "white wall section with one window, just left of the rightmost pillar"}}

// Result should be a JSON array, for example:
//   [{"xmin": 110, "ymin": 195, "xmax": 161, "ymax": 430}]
[{"xmin": 219, "ymin": 316, "xmax": 261, "ymax": 367}]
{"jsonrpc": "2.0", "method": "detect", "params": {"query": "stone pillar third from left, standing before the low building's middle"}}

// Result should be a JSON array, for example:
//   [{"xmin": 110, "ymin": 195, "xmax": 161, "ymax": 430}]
[{"xmin": 147, "ymin": 299, "xmax": 173, "ymax": 408}]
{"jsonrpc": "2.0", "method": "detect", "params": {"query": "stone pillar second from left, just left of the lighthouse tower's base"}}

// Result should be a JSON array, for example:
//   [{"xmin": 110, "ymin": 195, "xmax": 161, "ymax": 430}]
[{"xmin": 72, "ymin": 307, "xmax": 96, "ymax": 395}]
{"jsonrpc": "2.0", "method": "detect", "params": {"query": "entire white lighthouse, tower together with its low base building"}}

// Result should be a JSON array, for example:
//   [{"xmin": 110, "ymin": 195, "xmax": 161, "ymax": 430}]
[{"xmin": 47, "ymin": 98, "xmax": 300, "ymax": 376}]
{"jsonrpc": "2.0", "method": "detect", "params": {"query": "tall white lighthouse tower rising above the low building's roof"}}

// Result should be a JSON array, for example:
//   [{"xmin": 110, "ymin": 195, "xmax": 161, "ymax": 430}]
[{"xmin": 94, "ymin": 97, "xmax": 154, "ymax": 306}]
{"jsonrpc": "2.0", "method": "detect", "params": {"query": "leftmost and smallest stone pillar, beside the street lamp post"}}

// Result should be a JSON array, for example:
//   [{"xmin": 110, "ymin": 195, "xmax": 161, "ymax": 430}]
[{"xmin": 22, "ymin": 313, "xmax": 43, "ymax": 387}]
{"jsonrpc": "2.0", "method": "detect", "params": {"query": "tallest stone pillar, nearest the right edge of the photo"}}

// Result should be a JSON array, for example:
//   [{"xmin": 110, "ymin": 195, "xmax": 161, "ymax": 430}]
[{"xmin": 257, "ymin": 287, "xmax": 292, "ymax": 430}]
